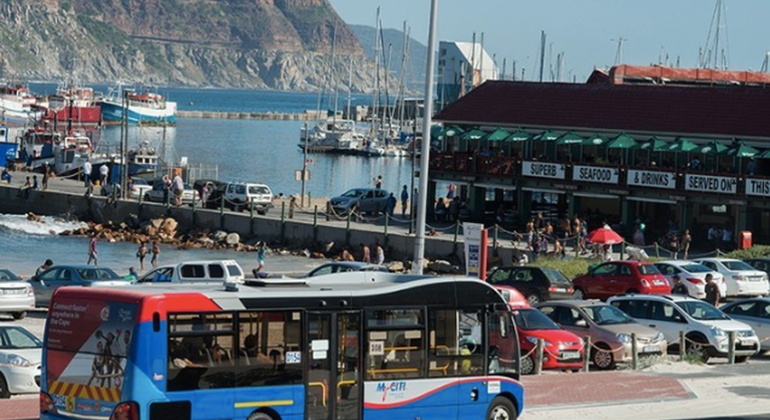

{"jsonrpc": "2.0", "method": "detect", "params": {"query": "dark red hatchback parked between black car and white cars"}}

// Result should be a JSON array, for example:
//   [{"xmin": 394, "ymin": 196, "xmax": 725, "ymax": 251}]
[{"xmin": 572, "ymin": 261, "xmax": 671, "ymax": 300}]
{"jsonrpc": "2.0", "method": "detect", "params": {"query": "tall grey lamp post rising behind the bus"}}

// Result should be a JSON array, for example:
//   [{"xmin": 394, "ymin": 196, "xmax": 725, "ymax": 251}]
[{"xmin": 412, "ymin": 0, "xmax": 438, "ymax": 274}]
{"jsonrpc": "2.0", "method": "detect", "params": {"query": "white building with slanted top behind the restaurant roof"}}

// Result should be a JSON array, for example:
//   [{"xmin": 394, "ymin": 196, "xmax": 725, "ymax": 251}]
[{"xmin": 438, "ymin": 41, "xmax": 499, "ymax": 104}]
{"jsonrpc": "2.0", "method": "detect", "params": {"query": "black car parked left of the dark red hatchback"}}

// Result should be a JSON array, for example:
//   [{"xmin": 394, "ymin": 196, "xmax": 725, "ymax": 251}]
[{"xmin": 487, "ymin": 267, "xmax": 574, "ymax": 305}]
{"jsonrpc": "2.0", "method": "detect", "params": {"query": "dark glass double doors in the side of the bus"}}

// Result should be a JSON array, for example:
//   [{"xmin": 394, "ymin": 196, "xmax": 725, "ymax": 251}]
[{"xmin": 305, "ymin": 312, "xmax": 363, "ymax": 420}]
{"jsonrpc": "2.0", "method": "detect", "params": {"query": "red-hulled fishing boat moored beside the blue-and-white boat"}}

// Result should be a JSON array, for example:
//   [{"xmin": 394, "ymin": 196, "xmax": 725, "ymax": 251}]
[{"xmin": 38, "ymin": 86, "xmax": 102, "ymax": 130}]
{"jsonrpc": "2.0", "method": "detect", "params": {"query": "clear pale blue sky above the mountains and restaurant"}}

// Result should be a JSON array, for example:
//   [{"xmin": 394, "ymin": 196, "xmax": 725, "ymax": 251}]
[{"xmin": 330, "ymin": 0, "xmax": 770, "ymax": 81}]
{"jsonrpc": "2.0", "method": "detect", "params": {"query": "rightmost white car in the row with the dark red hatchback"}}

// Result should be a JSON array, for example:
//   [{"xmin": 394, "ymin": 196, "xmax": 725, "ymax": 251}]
[{"xmin": 695, "ymin": 258, "xmax": 770, "ymax": 296}]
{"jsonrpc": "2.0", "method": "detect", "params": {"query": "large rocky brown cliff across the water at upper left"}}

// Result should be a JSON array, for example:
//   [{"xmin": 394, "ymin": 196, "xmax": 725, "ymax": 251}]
[{"xmin": 0, "ymin": 0, "xmax": 384, "ymax": 91}]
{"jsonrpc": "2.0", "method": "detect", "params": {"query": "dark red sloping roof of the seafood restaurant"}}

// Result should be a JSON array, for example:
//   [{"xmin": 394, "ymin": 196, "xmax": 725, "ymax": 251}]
[{"xmin": 436, "ymin": 81, "xmax": 770, "ymax": 140}]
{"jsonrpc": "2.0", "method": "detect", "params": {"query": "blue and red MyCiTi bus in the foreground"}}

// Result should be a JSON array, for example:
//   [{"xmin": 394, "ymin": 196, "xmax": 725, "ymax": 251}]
[{"xmin": 40, "ymin": 272, "xmax": 524, "ymax": 420}]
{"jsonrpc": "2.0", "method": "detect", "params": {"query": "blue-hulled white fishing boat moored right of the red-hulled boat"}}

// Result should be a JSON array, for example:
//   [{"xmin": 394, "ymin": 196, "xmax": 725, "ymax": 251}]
[{"xmin": 101, "ymin": 86, "xmax": 177, "ymax": 125}]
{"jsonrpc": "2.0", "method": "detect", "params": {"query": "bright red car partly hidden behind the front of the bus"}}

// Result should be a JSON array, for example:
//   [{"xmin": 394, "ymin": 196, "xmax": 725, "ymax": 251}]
[{"xmin": 497, "ymin": 286, "xmax": 585, "ymax": 375}]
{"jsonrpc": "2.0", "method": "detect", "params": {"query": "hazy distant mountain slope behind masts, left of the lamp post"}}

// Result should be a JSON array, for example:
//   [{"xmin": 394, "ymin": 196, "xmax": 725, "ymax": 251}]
[{"xmin": 349, "ymin": 25, "xmax": 428, "ymax": 92}]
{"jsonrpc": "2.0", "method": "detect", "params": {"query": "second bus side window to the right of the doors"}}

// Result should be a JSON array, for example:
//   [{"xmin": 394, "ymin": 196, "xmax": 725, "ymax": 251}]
[{"xmin": 428, "ymin": 310, "xmax": 484, "ymax": 377}]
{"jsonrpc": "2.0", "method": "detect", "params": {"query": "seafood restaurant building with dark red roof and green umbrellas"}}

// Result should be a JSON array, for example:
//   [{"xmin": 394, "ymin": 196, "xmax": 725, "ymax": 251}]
[{"xmin": 429, "ymin": 66, "xmax": 770, "ymax": 243}]
